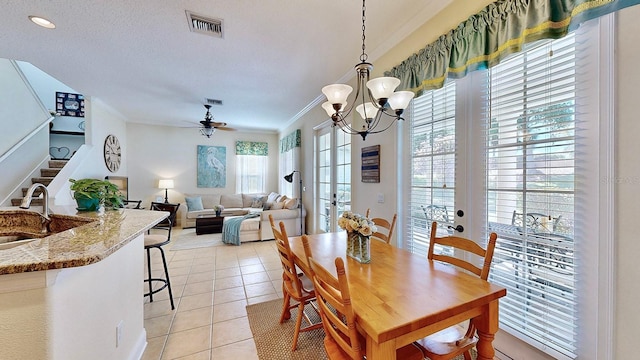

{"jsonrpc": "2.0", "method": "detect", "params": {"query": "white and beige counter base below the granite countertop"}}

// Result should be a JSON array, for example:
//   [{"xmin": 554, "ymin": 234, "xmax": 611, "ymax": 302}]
[{"xmin": 0, "ymin": 235, "xmax": 146, "ymax": 360}]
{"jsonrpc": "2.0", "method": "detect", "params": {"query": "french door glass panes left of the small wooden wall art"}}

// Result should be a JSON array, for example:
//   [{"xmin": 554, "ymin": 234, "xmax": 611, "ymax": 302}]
[{"xmin": 314, "ymin": 126, "xmax": 351, "ymax": 232}]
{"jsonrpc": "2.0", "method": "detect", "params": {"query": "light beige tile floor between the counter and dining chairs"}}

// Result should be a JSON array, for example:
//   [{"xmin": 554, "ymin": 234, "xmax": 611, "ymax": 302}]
[{"xmin": 143, "ymin": 229, "xmax": 282, "ymax": 360}]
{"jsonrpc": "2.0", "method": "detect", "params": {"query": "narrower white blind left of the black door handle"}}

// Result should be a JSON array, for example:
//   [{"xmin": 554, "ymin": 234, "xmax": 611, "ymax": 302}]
[{"xmin": 406, "ymin": 81, "xmax": 456, "ymax": 256}]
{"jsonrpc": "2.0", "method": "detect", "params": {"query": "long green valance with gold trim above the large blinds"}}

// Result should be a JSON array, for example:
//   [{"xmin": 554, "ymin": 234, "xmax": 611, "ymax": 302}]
[{"xmin": 385, "ymin": 0, "xmax": 640, "ymax": 96}]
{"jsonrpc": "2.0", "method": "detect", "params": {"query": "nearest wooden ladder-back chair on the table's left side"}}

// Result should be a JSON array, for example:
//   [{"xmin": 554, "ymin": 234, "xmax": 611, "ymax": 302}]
[{"xmin": 303, "ymin": 253, "xmax": 424, "ymax": 360}]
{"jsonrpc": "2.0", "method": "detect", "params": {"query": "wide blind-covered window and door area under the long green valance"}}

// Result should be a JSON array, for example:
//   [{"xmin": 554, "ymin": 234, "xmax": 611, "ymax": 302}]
[{"xmin": 405, "ymin": 18, "xmax": 613, "ymax": 359}]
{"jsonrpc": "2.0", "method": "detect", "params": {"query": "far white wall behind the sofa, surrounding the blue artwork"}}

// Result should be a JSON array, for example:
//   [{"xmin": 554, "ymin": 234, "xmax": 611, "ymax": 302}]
[{"xmin": 125, "ymin": 123, "xmax": 279, "ymax": 207}]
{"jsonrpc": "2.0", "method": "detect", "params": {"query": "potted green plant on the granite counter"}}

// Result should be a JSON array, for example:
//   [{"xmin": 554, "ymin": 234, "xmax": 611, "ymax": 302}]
[{"xmin": 69, "ymin": 179, "xmax": 124, "ymax": 211}]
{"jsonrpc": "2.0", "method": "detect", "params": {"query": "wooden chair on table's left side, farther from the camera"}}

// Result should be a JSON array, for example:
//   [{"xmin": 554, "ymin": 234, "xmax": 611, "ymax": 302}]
[{"xmin": 269, "ymin": 215, "xmax": 322, "ymax": 351}]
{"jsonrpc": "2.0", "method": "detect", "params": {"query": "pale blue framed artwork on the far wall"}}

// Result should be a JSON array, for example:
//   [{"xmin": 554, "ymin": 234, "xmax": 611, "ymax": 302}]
[{"xmin": 198, "ymin": 145, "xmax": 227, "ymax": 188}]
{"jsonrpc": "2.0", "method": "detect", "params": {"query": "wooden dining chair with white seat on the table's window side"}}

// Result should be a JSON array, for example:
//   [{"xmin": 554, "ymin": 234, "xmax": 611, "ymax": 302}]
[{"xmin": 416, "ymin": 221, "xmax": 498, "ymax": 360}]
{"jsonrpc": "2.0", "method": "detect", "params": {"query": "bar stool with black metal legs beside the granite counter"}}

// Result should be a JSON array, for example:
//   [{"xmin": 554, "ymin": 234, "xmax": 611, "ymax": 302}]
[{"xmin": 144, "ymin": 204, "xmax": 180, "ymax": 310}]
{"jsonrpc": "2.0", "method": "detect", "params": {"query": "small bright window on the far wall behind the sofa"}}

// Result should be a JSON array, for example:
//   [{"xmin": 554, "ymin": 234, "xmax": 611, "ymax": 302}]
[{"xmin": 236, "ymin": 155, "xmax": 268, "ymax": 194}]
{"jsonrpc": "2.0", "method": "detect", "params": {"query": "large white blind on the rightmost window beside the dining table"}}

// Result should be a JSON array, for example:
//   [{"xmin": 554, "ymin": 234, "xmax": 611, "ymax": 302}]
[{"xmin": 484, "ymin": 34, "xmax": 579, "ymax": 358}]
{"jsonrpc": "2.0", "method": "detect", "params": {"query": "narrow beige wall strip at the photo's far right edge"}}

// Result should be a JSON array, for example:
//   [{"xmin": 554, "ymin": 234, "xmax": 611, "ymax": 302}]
[{"xmin": 612, "ymin": 6, "xmax": 640, "ymax": 359}]
